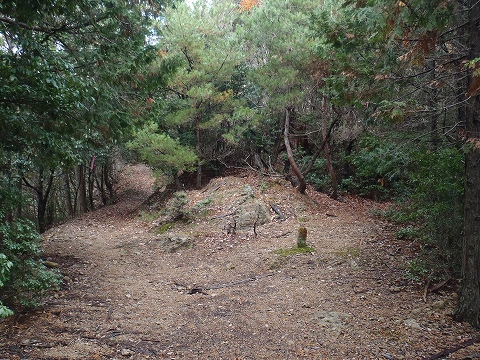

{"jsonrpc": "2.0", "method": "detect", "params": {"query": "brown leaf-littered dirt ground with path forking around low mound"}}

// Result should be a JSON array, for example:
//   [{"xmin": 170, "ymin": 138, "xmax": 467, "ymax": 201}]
[{"xmin": 0, "ymin": 165, "xmax": 480, "ymax": 359}]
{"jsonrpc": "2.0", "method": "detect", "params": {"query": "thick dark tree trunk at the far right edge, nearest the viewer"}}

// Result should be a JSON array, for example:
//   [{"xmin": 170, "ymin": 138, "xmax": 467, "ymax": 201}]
[{"xmin": 454, "ymin": 1, "xmax": 480, "ymax": 327}]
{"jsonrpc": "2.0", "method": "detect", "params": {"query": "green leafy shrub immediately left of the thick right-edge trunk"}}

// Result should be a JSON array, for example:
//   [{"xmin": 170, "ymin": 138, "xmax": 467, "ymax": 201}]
[{"xmin": 378, "ymin": 147, "xmax": 464, "ymax": 281}]
